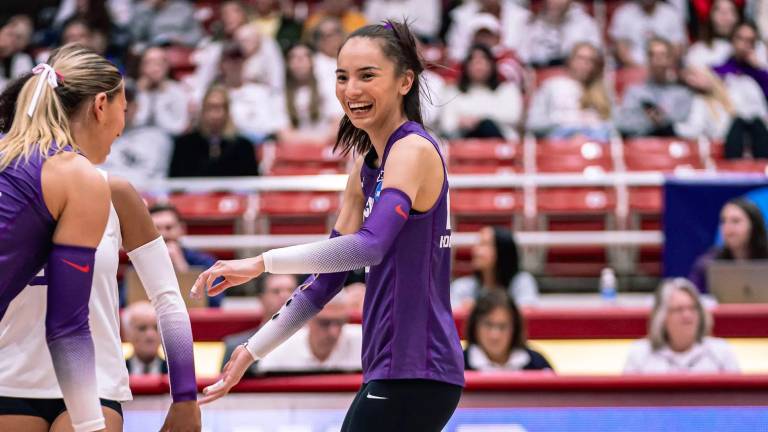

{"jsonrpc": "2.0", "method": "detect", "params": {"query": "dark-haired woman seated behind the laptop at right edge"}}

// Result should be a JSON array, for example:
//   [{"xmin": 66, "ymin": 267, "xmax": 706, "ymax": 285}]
[{"xmin": 689, "ymin": 198, "xmax": 768, "ymax": 293}]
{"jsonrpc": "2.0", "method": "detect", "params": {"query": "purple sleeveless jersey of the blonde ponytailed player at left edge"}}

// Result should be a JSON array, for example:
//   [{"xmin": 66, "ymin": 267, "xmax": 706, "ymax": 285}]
[{"xmin": 0, "ymin": 150, "xmax": 56, "ymax": 319}]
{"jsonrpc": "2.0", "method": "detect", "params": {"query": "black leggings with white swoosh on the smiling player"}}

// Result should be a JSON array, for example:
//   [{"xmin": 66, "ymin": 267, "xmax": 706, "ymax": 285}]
[{"xmin": 341, "ymin": 379, "xmax": 462, "ymax": 432}]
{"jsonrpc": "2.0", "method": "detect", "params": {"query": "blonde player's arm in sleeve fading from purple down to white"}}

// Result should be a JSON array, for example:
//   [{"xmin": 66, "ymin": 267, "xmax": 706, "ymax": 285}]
[{"xmin": 42, "ymin": 153, "xmax": 110, "ymax": 432}]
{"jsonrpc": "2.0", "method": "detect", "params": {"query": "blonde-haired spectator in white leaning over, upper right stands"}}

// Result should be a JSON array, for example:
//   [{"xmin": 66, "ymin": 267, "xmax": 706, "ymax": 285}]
[{"xmin": 674, "ymin": 68, "xmax": 735, "ymax": 141}]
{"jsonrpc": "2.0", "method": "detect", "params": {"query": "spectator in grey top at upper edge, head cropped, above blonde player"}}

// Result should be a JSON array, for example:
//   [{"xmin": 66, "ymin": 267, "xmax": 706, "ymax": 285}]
[{"xmin": 131, "ymin": 0, "xmax": 203, "ymax": 53}]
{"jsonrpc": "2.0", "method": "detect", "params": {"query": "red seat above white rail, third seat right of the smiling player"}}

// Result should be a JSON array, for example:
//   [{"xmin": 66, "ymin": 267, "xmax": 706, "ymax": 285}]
[{"xmin": 624, "ymin": 137, "xmax": 704, "ymax": 172}]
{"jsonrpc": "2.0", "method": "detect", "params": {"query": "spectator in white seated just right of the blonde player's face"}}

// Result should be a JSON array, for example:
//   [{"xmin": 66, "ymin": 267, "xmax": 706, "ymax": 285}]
[{"xmin": 134, "ymin": 47, "xmax": 189, "ymax": 135}]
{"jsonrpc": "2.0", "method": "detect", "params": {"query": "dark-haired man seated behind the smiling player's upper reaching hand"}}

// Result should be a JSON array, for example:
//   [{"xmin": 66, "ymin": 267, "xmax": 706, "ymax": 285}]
[{"xmin": 149, "ymin": 204, "xmax": 224, "ymax": 307}]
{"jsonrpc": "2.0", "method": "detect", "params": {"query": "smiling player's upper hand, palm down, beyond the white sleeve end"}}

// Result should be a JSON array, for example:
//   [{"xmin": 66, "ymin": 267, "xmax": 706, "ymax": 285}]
[{"xmin": 190, "ymin": 255, "xmax": 264, "ymax": 298}]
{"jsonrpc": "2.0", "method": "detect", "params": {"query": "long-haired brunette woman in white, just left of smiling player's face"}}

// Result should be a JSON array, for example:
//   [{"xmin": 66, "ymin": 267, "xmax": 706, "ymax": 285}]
[{"xmin": 278, "ymin": 44, "xmax": 344, "ymax": 146}]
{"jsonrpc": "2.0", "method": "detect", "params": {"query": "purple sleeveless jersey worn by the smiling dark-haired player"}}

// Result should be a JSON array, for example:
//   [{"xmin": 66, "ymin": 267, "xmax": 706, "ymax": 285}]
[{"xmin": 360, "ymin": 121, "xmax": 464, "ymax": 386}]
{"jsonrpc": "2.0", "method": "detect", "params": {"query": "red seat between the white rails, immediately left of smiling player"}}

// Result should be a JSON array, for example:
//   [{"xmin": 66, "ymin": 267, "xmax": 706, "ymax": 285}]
[{"xmin": 259, "ymin": 192, "xmax": 340, "ymax": 234}]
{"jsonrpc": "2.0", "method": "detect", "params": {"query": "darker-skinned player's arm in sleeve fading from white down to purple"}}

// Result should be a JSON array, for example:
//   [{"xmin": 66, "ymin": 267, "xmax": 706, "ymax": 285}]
[{"xmin": 109, "ymin": 177, "xmax": 201, "ymax": 432}]
